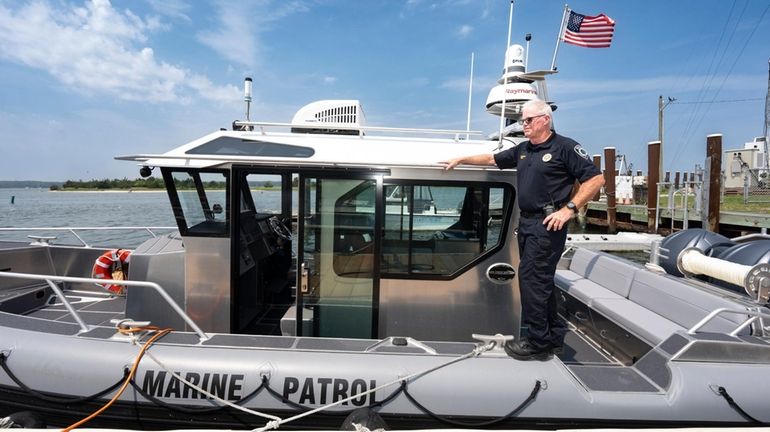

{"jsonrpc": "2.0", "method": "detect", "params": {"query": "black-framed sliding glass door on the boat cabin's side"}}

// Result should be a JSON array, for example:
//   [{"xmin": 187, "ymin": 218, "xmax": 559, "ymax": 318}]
[{"xmin": 297, "ymin": 175, "xmax": 382, "ymax": 338}]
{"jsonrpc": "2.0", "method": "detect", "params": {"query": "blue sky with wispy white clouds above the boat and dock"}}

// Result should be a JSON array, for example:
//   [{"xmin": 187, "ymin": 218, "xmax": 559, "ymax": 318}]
[{"xmin": 0, "ymin": 0, "xmax": 770, "ymax": 180}]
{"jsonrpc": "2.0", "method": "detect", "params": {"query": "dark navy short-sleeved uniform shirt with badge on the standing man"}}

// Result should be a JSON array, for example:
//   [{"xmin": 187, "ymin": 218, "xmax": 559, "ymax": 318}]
[{"xmin": 494, "ymin": 132, "xmax": 601, "ymax": 212}]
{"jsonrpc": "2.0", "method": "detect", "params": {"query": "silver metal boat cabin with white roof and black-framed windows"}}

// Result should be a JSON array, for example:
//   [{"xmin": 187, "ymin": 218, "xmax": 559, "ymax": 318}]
[{"xmin": 121, "ymin": 101, "xmax": 519, "ymax": 341}]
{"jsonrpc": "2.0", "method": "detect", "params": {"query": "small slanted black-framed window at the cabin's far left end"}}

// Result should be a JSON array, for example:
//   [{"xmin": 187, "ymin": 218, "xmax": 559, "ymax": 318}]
[{"xmin": 171, "ymin": 171, "xmax": 230, "ymax": 235}]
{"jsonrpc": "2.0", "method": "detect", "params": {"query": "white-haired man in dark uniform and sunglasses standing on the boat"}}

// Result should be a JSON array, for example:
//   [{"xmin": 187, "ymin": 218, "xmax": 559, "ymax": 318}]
[{"xmin": 442, "ymin": 100, "xmax": 604, "ymax": 360}]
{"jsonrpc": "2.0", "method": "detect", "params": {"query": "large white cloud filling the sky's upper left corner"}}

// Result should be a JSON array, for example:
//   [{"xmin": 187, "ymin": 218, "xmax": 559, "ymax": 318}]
[{"xmin": 0, "ymin": 0, "xmax": 239, "ymax": 103}]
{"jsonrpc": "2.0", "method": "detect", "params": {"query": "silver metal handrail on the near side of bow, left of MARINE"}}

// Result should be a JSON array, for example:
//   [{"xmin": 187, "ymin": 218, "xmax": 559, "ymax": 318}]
[{"xmin": 0, "ymin": 271, "xmax": 209, "ymax": 341}]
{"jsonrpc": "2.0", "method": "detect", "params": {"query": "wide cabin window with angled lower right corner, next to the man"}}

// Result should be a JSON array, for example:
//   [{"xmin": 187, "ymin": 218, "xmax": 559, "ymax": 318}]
[{"xmin": 381, "ymin": 184, "xmax": 511, "ymax": 277}]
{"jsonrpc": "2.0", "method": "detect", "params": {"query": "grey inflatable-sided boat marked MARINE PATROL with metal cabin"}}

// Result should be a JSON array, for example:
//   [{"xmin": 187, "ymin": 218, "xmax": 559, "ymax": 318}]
[{"xmin": 0, "ymin": 44, "xmax": 770, "ymax": 430}]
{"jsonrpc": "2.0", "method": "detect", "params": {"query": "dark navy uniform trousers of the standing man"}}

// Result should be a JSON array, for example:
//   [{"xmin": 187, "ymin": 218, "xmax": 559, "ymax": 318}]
[{"xmin": 518, "ymin": 217, "xmax": 567, "ymax": 350}]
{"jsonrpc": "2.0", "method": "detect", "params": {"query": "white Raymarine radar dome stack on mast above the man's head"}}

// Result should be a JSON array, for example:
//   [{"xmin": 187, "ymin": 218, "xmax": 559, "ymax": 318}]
[{"xmin": 486, "ymin": 44, "xmax": 556, "ymax": 120}]
